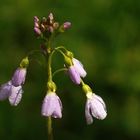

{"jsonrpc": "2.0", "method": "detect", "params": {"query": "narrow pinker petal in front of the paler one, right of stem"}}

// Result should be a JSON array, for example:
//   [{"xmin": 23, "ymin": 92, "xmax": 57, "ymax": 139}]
[{"xmin": 68, "ymin": 65, "xmax": 81, "ymax": 85}]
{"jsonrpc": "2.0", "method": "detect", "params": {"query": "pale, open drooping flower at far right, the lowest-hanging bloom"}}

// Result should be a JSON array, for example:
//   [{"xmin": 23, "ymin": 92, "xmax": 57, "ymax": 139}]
[{"xmin": 85, "ymin": 93, "xmax": 107, "ymax": 124}]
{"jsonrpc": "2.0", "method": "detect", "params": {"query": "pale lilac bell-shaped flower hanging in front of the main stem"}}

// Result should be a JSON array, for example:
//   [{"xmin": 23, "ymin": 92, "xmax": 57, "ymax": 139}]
[{"xmin": 41, "ymin": 92, "xmax": 62, "ymax": 118}]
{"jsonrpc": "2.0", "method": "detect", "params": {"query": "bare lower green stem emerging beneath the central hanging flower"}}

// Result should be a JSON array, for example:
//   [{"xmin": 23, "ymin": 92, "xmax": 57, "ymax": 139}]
[{"xmin": 47, "ymin": 116, "xmax": 53, "ymax": 140}]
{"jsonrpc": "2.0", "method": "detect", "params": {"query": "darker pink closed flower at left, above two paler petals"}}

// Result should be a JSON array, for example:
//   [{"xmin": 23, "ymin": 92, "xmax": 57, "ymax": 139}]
[{"xmin": 11, "ymin": 68, "xmax": 26, "ymax": 87}]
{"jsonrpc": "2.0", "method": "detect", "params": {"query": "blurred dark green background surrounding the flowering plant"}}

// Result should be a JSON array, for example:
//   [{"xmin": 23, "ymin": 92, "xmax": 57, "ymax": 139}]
[{"xmin": 0, "ymin": 0, "xmax": 140, "ymax": 140}]
